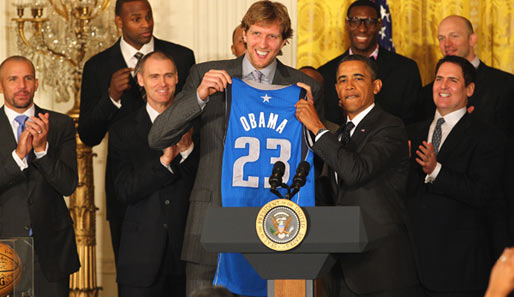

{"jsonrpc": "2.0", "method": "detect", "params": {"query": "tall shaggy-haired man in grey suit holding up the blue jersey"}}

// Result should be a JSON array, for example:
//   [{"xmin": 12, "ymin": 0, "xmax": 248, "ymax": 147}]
[{"xmin": 149, "ymin": 1, "xmax": 320, "ymax": 293}]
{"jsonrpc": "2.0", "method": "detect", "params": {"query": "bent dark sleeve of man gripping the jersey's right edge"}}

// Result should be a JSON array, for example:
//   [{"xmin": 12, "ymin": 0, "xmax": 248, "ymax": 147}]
[{"xmin": 313, "ymin": 120, "xmax": 407, "ymax": 186}]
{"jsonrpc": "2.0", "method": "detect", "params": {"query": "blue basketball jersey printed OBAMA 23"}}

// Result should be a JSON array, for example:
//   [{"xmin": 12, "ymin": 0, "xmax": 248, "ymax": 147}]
[{"xmin": 213, "ymin": 78, "xmax": 314, "ymax": 296}]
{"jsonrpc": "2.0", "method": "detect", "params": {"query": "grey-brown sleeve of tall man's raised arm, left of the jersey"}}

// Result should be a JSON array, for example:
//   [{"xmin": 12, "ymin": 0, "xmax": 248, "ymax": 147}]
[{"xmin": 148, "ymin": 65, "xmax": 201, "ymax": 149}]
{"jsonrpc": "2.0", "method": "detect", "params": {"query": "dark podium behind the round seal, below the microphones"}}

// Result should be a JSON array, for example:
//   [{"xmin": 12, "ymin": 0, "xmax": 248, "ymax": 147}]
[{"xmin": 201, "ymin": 206, "xmax": 380, "ymax": 297}]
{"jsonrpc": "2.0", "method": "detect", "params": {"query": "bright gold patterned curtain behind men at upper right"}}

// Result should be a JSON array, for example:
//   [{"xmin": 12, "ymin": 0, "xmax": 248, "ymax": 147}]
[{"xmin": 297, "ymin": 0, "xmax": 514, "ymax": 84}]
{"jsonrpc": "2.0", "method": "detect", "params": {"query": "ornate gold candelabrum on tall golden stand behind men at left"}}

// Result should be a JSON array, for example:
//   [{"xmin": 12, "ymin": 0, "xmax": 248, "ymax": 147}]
[{"xmin": 11, "ymin": 0, "xmax": 117, "ymax": 297}]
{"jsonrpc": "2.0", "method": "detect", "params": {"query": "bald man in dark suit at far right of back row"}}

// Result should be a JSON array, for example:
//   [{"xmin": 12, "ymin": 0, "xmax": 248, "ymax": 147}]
[{"xmin": 421, "ymin": 15, "xmax": 514, "ymax": 260}]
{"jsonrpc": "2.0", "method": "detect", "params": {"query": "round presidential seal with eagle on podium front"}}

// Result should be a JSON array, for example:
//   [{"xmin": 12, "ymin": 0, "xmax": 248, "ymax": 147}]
[{"xmin": 256, "ymin": 199, "xmax": 307, "ymax": 251}]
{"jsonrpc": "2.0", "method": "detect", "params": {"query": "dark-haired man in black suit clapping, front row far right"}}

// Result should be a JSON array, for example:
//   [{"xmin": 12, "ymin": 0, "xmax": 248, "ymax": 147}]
[{"xmin": 407, "ymin": 56, "xmax": 504, "ymax": 297}]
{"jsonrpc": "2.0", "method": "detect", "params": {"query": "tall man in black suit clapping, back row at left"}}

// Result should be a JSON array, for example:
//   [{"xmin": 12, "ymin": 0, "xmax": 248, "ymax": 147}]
[{"xmin": 78, "ymin": 0, "xmax": 195, "ymax": 257}]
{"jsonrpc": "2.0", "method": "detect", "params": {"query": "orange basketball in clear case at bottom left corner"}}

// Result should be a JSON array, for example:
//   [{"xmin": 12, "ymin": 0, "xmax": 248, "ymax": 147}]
[{"xmin": 0, "ymin": 242, "xmax": 21, "ymax": 297}]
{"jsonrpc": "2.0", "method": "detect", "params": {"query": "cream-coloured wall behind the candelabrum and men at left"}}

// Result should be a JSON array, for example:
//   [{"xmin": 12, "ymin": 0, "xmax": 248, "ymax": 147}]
[{"xmin": 0, "ymin": 0, "xmax": 297, "ymax": 297}]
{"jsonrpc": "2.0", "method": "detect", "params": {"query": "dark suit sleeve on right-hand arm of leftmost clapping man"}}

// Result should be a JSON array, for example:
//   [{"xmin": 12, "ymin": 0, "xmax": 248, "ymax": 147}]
[{"xmin": 31, "ymin": 113, "xmax": 78, "ymax": 196}]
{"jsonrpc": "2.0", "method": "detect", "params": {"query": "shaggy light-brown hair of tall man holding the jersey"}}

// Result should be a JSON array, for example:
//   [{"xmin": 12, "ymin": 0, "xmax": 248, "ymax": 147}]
[{"xmin": 241, "ymin": 0, "xmax": 293, "ymax": 40}]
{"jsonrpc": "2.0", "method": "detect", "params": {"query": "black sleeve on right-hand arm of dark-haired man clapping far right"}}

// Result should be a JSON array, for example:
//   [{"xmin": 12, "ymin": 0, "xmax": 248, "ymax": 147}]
[{"xmin": 431, "ymin": 133, "xmax": 504, "ymax": 207}]
